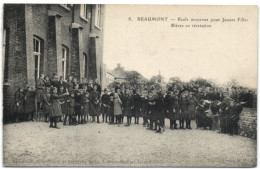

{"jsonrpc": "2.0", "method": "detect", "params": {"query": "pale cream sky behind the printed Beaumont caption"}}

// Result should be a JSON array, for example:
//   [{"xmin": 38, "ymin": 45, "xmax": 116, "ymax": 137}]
[{"xmin": 103, "ymin": 5, "xmax": 258, "ymax": 88}]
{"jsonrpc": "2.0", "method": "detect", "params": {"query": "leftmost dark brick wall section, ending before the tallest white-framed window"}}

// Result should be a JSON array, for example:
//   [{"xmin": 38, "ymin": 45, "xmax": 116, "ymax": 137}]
[{"xmin": 3, "ymin": 4, "xmax": 27, "ymax": 119}]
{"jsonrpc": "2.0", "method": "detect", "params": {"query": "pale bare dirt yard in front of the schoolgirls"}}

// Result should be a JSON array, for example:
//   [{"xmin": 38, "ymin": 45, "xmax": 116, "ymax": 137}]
[{"xmin": 3, "ymin": 120, "xmax": 257, "ymax": 167}]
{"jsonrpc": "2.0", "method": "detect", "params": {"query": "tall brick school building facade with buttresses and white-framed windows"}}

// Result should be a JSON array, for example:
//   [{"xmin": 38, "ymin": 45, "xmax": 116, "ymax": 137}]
[{"xmin": 2, "ymin": 4, "xmax": 105, "ymax": 120}]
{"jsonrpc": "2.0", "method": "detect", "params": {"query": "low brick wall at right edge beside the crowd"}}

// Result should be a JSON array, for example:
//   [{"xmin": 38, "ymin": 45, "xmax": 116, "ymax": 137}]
[{"xmin": 239, "ymin": 108, "xmax": 257, "ymax": 139}]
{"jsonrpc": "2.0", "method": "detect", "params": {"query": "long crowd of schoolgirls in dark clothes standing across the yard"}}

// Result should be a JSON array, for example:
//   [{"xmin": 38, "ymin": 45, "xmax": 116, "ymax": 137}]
[{"xmin": 14, "ymin": 74, "xmax": 253, "ymax": 135}]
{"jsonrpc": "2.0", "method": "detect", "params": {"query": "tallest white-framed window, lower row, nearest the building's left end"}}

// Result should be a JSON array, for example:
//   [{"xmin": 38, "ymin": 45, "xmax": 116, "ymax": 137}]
[{"xmin": 33, "ymin": 38, "xmax": 41, "ymax": 81}]
